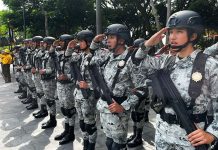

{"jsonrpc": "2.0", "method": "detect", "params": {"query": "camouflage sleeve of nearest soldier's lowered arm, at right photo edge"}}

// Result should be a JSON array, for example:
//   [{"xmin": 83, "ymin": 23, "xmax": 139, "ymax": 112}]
[{"xmin": 206, "ymin": 58, "xmax": 218, "ymax": 138}]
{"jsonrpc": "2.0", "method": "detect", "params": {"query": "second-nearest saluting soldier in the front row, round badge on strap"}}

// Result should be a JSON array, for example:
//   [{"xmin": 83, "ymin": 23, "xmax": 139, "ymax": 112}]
[{"xmin": 90, "ymin": 24, "xmax": 138, "ymax": 150}]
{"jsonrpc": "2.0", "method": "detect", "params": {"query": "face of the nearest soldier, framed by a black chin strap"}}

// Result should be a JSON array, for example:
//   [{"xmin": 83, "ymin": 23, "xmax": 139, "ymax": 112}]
[{"xmin": 169, "ymin": 28, "xmax": 188, "ymax": 46}]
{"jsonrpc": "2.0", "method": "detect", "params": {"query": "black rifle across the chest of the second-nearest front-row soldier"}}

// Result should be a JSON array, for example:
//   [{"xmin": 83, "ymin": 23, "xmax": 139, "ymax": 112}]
[{"xmin": 89, "ymin": 64, "xmax": 113, "ymax": 105}]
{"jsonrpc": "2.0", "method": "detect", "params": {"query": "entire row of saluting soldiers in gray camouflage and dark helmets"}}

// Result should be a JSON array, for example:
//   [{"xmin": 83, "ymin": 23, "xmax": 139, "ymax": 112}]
[{"xmin": 11, "ymin": 11, "xmax": 218, "ymax": 150}]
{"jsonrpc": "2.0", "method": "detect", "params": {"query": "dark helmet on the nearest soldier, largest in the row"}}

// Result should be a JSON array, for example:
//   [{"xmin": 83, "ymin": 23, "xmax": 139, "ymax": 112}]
[{"xmin": 166, "ymin": 10, "xmax": 203, "ymax": 36}]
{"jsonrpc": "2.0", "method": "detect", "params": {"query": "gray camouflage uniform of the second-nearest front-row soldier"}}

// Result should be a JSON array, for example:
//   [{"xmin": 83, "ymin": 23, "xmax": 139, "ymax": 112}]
[{"xmin": 90, "ymin": 42, "xmax": 138, "ymax": 144}]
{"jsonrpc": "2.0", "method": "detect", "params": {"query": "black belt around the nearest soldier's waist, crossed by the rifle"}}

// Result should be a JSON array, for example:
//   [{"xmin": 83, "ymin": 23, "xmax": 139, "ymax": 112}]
[{"xmin": 160, "ymin": 111, "xmax": 207, "ymax": 125}]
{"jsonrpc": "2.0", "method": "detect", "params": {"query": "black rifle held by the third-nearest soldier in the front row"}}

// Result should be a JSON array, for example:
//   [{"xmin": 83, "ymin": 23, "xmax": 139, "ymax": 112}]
[{"xmin": 71, "ymin": 62, "xmax": 89, "ymax": 99}]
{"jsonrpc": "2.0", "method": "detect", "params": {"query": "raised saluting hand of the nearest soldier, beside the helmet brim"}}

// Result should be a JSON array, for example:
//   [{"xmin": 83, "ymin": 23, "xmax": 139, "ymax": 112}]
[{"xmin": 144, "ymin": 28, "xmax": 168, "ymax": 46}]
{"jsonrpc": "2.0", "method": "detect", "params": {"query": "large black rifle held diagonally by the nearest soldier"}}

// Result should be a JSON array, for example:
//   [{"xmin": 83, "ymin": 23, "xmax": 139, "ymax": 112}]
[{"xmin": 152, "ymin": 69, "xmax": 207, "ymax": 150}]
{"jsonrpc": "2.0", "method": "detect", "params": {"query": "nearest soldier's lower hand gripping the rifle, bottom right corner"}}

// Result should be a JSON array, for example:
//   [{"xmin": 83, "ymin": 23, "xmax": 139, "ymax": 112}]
[{"xmin": 188, "ymin": 129, "xmax": 215, "ymax": 146}]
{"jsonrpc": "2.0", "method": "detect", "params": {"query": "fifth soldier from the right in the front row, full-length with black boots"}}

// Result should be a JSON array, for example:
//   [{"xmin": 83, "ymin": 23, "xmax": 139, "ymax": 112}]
[{"xmin": 39, "ymin": 36, "xmax": 57, "ymax": 129}]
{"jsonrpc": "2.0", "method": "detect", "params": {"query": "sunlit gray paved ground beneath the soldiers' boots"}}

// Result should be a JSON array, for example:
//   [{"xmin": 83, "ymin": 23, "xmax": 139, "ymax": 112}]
[{"xmin": 0, "ymin": 67, "xmax": 155, "ymax": 150}]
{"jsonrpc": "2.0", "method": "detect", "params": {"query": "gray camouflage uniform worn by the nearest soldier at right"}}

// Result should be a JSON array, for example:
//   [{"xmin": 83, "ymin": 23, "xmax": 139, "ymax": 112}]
[{"xmin": 136, "ymin": 49, "xmax": 218, "ymax": 150}]
